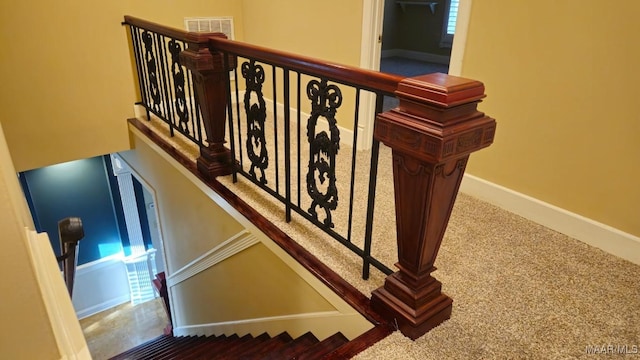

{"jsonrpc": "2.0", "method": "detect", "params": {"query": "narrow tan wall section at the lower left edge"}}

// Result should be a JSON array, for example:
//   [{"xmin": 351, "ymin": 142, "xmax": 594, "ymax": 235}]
[{"xmin": 0, "ymin": 123, "xmax": 60, "ymax": 359}]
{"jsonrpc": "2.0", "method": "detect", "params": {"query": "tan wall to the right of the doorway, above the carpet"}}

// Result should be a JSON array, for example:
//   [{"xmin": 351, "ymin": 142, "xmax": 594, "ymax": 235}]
[{"xmin": 462, "ymin": 0, "xmax": 640, "ymax": 236}]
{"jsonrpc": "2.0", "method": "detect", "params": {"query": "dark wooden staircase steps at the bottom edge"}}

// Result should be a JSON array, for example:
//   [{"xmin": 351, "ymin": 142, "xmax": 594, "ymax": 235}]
[{"xmin": 111, "ymin": 332, "xmax": 349, "ymax": 360}]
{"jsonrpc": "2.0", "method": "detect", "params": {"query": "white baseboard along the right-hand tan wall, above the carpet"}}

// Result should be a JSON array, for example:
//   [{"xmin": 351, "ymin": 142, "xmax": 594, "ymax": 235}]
[{"xmin": 460, "ymin": 174, "xmax": 640, "ymax": 265}]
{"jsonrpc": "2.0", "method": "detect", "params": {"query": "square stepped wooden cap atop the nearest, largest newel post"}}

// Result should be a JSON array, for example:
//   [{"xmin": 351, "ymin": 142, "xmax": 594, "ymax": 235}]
[{"xmin": 374, "ymin": 73, "xmax": 496, "ymax": 163}]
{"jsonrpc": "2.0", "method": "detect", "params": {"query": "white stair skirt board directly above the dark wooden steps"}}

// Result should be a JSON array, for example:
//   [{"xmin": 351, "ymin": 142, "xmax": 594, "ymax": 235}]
[{"xmin": 173, "ymin": 311, "xmax": 371, "ymax": 340}]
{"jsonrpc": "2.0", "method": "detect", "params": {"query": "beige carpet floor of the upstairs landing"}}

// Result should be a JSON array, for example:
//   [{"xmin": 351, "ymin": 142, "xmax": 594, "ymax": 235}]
[{"xmin": 136, "ymin": 113, "xmax": 640, "ymax": 360}]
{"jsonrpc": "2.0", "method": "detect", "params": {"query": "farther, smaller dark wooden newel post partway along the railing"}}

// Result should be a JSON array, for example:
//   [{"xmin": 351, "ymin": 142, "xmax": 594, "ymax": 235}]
[{"xmin": 180, "ymin": 34, "xmax": 235, "ymax": 179}]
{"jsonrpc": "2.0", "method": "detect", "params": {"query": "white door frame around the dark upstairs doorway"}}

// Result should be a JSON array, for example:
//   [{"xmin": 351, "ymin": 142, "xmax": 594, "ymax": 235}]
[{"xmin": 354, "ymin": 0, "xmax": 473, "ymax": 150}]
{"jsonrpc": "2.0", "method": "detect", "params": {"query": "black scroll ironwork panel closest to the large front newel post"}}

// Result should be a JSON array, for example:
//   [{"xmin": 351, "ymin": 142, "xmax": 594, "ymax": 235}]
[{"xmin": 307, "ymin": 79, "xmax": 342, "ymax": 228}]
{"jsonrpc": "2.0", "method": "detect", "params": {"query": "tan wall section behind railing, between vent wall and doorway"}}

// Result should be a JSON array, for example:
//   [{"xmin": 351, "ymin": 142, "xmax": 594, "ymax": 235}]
[{"xmin": 243, "ymin": 0, "xmax": 362, "ymax": 129}]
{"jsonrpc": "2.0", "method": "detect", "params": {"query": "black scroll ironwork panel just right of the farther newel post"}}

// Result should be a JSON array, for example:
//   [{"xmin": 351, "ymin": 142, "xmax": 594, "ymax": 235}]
[{"xmin": 242, "ymin": 60, "xmax": 269, "ymax": 184}]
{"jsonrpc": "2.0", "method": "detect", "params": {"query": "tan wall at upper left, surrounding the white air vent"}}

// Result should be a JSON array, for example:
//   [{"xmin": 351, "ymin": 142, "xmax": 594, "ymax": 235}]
[{"xmin": 0, "ymin": 0, "xmax": 242, "ymax": 171}]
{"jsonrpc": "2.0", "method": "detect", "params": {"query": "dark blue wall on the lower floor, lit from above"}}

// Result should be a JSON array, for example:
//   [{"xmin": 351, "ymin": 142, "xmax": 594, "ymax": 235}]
[{"xmin": 20, "ymin": 156, "xmax": 128, "ymax": 265}]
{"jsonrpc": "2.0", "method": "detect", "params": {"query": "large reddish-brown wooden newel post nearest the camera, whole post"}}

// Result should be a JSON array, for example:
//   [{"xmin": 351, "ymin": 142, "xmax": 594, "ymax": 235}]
[{"xmin": 371, "ymin": 74, "xmax": 496, "ymax": 340}]
